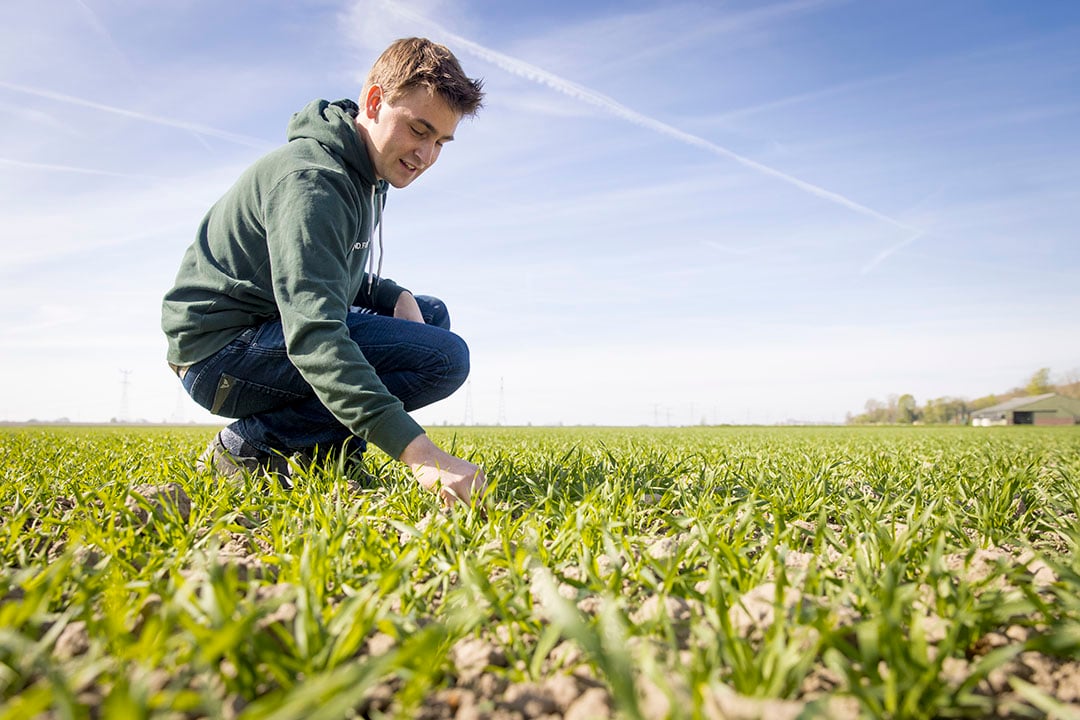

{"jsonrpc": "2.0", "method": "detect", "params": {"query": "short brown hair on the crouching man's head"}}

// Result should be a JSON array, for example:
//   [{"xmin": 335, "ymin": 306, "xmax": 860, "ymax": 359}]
[{"xmin": 364, "ymin": 38, "xmax": 484, "ymax": 116}]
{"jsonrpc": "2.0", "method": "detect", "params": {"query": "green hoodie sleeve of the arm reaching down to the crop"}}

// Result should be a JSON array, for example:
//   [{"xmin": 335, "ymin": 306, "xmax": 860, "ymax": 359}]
[{"xmin": 262, "ymin": 171, "xmax": 423, "ymax": 458}]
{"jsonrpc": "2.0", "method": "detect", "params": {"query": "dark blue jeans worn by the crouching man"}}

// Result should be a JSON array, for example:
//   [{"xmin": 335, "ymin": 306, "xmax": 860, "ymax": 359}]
[{"xmin": 181, "ymin": 295, "xmax": 469, "ymax": 454}]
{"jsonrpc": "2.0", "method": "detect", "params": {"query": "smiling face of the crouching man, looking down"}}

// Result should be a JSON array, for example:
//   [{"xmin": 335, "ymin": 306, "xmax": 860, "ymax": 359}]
[{"xmin": 356, "ymin": 85, "xmax": 461, "ymax": 188}]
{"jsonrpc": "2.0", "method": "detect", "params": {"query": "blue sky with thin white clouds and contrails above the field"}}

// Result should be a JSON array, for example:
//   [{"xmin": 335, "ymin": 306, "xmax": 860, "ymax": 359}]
[{"xmin": 0, "ymin": 0, "xmax": 1080, "ymax": 424}]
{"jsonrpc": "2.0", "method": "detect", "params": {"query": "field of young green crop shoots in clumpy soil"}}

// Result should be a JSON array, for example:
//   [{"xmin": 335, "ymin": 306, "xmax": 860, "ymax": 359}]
[{"xmin": 0, "ymin": 427, "xmax": 1080, "ymax": 720}]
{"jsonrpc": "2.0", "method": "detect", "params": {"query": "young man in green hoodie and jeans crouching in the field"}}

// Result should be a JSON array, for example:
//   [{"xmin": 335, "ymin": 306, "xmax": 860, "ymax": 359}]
[{"xmin": 162, "ymin": 38, "xmax": 485, "ymax": 503}]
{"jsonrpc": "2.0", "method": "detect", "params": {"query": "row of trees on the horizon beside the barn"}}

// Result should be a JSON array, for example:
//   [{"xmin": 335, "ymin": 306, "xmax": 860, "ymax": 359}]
[{"xmin": 848, "ymin": 367, "xmax": 1080, "ymax": 425}]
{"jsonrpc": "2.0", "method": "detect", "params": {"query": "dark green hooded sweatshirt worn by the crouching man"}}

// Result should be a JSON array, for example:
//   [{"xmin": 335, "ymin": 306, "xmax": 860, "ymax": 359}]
[{"xmin": 161, "ymin": 100, "xmax": 423, "ymax": 458}]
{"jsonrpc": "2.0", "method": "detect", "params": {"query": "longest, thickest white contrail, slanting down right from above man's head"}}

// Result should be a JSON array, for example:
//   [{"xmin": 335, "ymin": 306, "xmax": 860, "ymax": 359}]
[{"xmin": 381, "ymin": 0, "xmax": 920, "ymax": 233}]
